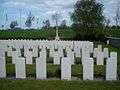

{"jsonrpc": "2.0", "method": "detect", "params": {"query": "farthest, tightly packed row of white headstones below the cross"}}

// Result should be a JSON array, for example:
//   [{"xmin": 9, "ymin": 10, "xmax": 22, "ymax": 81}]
[{"xmin": 0, "ymin": 40, "xmax": 93, "ymax": 49}]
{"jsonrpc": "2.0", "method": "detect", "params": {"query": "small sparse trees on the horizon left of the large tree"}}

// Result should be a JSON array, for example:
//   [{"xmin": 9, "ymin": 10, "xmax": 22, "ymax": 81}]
[{"xmin": 10, "ymin": 12, "xmax": 67, "ymax": 29}]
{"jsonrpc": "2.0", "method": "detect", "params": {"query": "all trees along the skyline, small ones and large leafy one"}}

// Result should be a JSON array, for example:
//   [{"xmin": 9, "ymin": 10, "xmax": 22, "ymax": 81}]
[{"xmin": 0, "ymin": 0, "xmax": 120, "ymax": 40}]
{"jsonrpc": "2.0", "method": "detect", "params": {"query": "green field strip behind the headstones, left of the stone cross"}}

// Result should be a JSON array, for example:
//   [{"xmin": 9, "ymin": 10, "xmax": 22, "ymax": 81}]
[{"xmin": 0, "ymin": 30, "xmax": 55, "ymax": 39}]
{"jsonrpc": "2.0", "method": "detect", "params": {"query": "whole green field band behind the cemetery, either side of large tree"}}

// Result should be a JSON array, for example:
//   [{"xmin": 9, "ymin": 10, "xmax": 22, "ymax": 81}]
[{"xmin": 0, "ymin": 29, "xmax": 120, "ymax": 40}]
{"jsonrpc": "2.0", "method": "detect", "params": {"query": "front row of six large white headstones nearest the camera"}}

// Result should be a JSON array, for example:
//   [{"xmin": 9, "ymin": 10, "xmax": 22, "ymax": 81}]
[{"xmin": 0, "ymin": 52, "xmax": 117, "ymax": 80}]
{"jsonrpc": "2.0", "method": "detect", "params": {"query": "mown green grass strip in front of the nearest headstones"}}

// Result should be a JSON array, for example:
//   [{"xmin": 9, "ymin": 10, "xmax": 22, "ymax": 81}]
[{"xmin": 0, "ymin": 79, "xmax": 120, "ymax": 90}]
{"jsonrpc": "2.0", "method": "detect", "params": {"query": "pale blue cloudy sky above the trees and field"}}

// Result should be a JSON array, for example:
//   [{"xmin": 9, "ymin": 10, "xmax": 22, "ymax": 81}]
[{"xmin": 0, "ymin": 0, "xmax": 120, "ymax": 28}]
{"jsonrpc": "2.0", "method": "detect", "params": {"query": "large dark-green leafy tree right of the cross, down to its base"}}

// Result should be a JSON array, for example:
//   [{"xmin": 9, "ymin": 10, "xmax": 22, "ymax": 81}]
[{"xmin": 71, "ymin": 0, "xmax": 105, "ymax": 41}]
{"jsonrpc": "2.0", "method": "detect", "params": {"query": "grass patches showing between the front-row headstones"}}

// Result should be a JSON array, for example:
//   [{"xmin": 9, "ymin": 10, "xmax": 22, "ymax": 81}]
[{"xmin": 3, "ymin": 64, "xmax": 110, "ymax": 79}]
